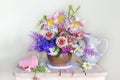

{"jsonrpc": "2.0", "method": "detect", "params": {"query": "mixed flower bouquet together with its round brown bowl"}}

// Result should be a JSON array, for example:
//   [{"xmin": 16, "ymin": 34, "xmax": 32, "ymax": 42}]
[{"xmin": 29, "ymin": 5, "xmax": 85, "ymax": 66}]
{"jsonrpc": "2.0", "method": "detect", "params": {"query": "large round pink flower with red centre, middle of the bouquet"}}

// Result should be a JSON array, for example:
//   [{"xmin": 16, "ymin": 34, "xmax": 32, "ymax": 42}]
[{"xmin": 56, "ymin": 36, "xmax": 67, "ymax": 48}]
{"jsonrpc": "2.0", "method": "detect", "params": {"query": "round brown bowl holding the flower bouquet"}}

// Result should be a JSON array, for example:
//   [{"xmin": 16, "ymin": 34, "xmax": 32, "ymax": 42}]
[{"xmin": 47, "ymin": 53, "xmax": 72, "ymax": 67}]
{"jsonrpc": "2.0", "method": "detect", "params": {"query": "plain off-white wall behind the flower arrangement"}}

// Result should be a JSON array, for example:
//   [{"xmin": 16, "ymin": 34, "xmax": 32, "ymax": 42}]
[{"xmin": 0, "ymin": 0, "xmax": 120, "ymax": 80}]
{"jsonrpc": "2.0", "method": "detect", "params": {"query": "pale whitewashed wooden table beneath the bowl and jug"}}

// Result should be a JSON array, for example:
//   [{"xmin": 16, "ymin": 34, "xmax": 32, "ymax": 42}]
[{"xmin": 14, "ymin": 62, "xmax": 107, "ymax": 80}]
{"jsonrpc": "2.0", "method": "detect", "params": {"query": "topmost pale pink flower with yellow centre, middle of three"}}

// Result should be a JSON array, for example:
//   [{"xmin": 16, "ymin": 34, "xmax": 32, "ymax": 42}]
[{"xmin": 54, "ymin": 12, "xmax": 66, "ymax": 24}]
